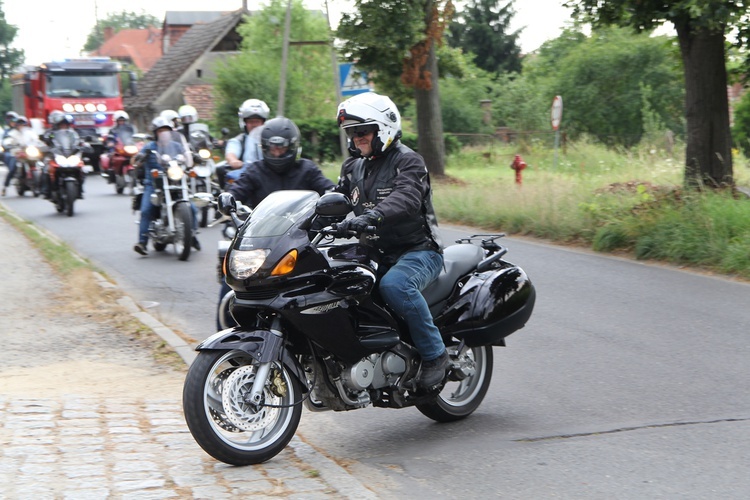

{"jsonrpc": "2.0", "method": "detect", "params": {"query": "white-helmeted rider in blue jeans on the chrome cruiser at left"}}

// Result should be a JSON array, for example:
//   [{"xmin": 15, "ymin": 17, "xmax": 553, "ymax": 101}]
[{"xmin": 133, "ymin": 116, "xmax": 201, "ymax": 255}]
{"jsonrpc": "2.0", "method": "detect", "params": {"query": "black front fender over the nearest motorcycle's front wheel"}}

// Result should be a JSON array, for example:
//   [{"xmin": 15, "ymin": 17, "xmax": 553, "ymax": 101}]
[{"xmin": 195, "ymin": 327, "xmax": 308, "ymax": 392}]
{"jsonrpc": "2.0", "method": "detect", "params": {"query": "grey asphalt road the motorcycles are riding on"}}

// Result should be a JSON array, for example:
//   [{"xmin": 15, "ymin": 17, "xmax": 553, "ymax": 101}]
[{"xmin": 0, "ymin": 174, "xmax": 750, "ymax": 499}]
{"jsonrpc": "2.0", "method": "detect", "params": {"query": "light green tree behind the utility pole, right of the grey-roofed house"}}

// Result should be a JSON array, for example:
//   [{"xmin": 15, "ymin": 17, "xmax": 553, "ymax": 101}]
[{"xmin": 214, "ymin": 0, "xmax": 338, "ymax": 130}]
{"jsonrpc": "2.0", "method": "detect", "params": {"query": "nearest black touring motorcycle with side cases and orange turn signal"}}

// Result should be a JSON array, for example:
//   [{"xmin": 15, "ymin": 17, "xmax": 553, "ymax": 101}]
[{"xmin": 183, "ymin": 191, "xmax": 536, "ymax": 465}]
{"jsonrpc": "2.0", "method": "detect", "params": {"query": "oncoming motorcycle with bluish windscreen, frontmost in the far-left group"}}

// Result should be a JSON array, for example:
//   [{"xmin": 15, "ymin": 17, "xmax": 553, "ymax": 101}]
[{"xmin": 47, "ymin": 130, "xmax": 90, "ymax": 217}]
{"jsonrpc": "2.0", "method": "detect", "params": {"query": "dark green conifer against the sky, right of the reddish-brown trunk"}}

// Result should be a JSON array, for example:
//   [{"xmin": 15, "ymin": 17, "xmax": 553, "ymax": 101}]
[{"xmin": 448, "ymin": 0, "xmax": 522, "ymax": 73}]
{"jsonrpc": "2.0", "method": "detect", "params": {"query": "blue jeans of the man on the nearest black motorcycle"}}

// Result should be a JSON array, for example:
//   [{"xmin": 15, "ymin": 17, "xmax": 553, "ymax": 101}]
[{"xmin": 379, "ymin": 250, "xmax": 445, "ymax": 361}]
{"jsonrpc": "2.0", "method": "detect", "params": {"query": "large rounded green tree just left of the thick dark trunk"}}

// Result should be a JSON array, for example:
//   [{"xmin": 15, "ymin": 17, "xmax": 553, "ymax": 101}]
[{"xmin": 524, "ymin": 27, "xmax": 684, "ymax": 147}]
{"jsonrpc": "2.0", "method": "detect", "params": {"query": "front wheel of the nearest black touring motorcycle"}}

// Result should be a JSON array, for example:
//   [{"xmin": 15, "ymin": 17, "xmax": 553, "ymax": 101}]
[{"xmin": 182, "ymin": 351, "xmax": 302, "ymax": 465}]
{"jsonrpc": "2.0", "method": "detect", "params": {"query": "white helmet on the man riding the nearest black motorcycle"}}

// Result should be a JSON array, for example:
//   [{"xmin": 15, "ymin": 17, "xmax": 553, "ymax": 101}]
[{"xmin": 337, "ymin": 92, "xmax": 401, "ymax": 155}]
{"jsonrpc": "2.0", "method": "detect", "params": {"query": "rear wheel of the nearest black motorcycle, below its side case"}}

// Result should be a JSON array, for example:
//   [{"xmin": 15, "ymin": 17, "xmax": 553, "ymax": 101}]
[{"xmin": 417, "ymin": 346, "xmax": 493, "ymax": 422}]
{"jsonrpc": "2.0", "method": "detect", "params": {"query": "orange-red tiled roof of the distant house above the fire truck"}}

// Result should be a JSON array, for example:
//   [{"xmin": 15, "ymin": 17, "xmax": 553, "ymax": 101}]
[{"xmin": 90, "ymin": 26, "xmax": 162, "ymax": 73}]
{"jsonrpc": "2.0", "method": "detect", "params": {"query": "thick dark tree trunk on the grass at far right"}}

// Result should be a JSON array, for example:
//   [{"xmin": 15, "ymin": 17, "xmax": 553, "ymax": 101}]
[{"xmin": 675, "ymin": 20, "xmax": 734, "ymax": 188}]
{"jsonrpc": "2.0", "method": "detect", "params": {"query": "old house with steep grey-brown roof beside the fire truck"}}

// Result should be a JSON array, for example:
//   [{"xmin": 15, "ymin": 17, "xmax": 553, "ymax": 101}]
[{"xmin": 125, "ymin": 8, "xmax": 248, "ymax": 131}]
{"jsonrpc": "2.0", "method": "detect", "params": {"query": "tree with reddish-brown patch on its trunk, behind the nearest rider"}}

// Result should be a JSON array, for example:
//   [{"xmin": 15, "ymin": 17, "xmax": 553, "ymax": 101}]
[{"xmin": 337, "ymin": 0, "xmax": 453, "ymax": 176}]
